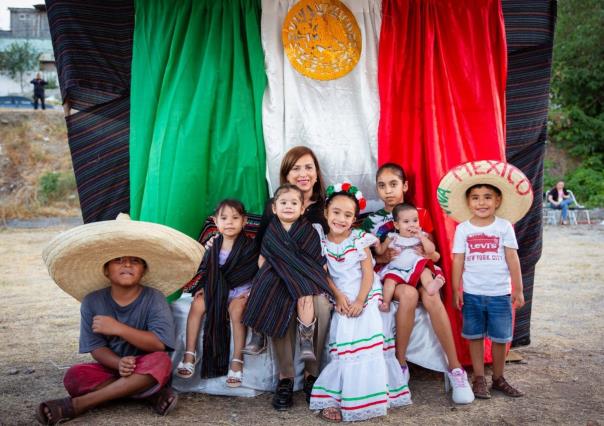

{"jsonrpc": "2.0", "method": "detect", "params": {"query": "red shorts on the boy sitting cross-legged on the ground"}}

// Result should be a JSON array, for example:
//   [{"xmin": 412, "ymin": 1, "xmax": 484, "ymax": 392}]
[{"xmin": 63, "ymin": 352, "xmax": 172, "ymax": 398}]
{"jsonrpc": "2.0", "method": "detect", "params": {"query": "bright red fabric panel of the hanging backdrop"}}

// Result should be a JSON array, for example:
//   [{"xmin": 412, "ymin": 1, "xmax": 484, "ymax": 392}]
[{"xmin": 378, "ymin": 0, "xmax": 507, "ymax": 365}]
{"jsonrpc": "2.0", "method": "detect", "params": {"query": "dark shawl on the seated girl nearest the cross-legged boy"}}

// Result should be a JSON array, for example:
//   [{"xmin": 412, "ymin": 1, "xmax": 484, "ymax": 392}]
[{"xmin": 194, "ymin": 234, "xmax": 258, "ymax": 378}]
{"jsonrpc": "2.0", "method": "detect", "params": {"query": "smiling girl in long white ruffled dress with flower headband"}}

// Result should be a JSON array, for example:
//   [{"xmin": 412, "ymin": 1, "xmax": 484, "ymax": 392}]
[{"xmin": 310, "ymin": 183, "xmax": 411, "ymax": 421}]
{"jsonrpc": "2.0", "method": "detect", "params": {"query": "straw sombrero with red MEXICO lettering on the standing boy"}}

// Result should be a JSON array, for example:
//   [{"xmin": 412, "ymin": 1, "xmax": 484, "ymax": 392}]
[{"xmin": 436, "ymin": 160, "xmax": 533, "ymax": 223}]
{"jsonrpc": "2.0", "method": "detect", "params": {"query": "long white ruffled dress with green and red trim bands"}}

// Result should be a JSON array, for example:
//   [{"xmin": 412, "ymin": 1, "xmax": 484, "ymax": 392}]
[{"xmin": 310, "ymin": 227, "xmax": 411, "ymax": 421}]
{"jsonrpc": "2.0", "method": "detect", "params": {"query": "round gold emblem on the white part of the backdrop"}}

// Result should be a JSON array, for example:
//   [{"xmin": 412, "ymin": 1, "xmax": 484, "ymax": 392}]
[{"xmin": 282, "ymin": 0, "xmax": 362, "ymax": 80}]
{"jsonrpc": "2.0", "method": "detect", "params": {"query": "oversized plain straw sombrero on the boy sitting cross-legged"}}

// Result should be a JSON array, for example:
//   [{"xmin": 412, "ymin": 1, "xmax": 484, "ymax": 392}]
[{"xmin": 42, "ymin": 214, "xmax": 204, "ymax": 301}]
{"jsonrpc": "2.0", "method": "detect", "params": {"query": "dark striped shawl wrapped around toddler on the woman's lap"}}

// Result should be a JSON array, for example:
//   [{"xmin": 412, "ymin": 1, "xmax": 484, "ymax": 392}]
[{"xmin": 243, "ymin": 217, "xmax": 331, "ymax": 337}]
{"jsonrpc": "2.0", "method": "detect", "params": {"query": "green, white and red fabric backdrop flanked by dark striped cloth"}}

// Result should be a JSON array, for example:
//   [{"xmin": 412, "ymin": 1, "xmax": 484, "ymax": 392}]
[{"xmin": 47, "ymin": 0, "xmax": 556, "ymax": 363}]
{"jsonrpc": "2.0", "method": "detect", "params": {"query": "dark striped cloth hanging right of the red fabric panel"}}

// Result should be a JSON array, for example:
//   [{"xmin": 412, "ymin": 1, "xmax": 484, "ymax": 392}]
[{"xmin": 502, "ymin": 0, "xmax": 556, "ymax": 346}]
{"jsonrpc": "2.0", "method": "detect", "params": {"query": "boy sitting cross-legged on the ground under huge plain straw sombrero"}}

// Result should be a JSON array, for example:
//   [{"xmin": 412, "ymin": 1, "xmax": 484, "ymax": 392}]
[{"xmin": 36, "ymin": 215, "xmax": 203, "ymax": 425}]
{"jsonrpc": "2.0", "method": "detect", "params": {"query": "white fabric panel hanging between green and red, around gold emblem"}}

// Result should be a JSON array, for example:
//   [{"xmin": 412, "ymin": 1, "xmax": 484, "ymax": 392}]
[{"xmin": 262, "ymin": 0, "xmax": 382, "ymax": 199}]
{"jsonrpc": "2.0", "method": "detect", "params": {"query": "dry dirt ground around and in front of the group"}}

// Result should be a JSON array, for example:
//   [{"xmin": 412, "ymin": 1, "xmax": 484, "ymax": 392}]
[{"xmin": 0, "ymin": 225, "xmax": 604, "ymax": 425}]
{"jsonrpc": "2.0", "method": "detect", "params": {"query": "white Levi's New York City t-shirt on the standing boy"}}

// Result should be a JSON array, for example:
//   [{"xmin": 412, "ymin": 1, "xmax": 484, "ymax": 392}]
[{"xmin": 453, "ymin": 217, "xmax": 518, "ymax": 296}]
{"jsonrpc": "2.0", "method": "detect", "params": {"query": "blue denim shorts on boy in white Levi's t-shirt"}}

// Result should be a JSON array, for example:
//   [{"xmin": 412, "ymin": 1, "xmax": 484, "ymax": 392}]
[{"xmin": 461, "ymin": 292, "xmax": 512, "ymax": 343}]
